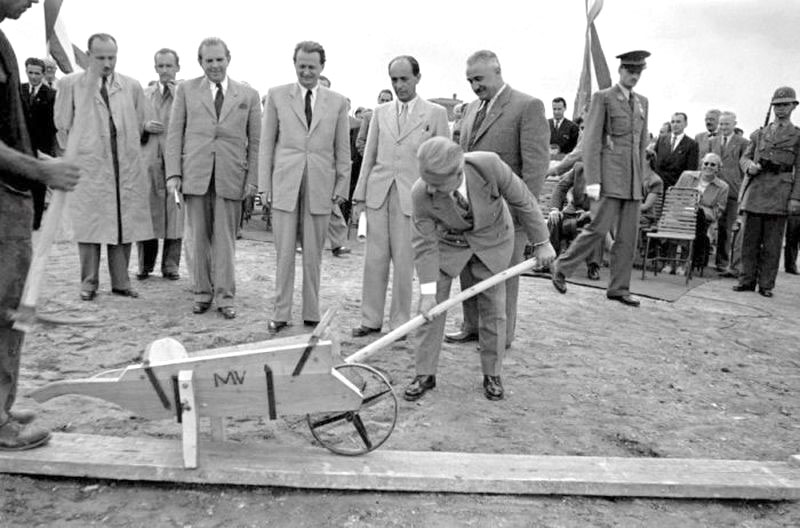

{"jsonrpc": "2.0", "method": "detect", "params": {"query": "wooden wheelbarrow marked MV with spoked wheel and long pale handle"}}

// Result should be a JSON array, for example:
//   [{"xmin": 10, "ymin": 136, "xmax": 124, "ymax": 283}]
[{"xmin": 32, "ymin": 259, "xmax": 535, "ymax": 468}]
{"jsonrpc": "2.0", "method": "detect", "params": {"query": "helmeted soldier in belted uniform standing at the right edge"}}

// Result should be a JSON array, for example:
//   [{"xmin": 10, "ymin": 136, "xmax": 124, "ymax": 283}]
[{"xmin": 733, "ymin": 86, "xmax": 800, "ymax": 297}]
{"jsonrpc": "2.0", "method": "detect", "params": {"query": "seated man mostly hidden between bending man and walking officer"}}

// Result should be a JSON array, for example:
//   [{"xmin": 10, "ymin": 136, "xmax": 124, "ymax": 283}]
[{"xmin": 547, "ymin": 162, "xmax": 603, "ymax": 280}]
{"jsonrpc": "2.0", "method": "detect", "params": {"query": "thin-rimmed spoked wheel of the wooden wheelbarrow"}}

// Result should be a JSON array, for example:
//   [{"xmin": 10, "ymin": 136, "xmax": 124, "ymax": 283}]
[{"xmin": 306, "ymin": 363, "xmax": 397, "ymax": 456}]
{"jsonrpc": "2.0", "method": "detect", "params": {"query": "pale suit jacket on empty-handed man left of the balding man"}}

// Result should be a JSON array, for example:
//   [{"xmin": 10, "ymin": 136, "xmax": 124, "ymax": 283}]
[{"xmin": 259, "ymin": 82, "xmax": 351, "ymax": 214}]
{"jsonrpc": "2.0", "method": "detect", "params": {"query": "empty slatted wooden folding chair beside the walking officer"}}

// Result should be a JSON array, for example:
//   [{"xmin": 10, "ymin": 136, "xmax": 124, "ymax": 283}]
[{"xmin": 642, "ymin": 187, "xmax": 698, "ymax": 284}]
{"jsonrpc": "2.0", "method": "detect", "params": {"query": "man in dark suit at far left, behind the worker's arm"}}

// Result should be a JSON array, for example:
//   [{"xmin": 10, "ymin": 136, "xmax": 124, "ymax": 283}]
[{"xmin": 20, "ymin": 57, "xmax": 56, "ymax": 230}]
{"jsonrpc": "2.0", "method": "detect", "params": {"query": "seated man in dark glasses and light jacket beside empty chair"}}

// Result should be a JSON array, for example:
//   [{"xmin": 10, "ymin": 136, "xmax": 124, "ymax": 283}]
[{"xmin": 664, "ymin": 152, "xmax": 728, "ymax": 275}]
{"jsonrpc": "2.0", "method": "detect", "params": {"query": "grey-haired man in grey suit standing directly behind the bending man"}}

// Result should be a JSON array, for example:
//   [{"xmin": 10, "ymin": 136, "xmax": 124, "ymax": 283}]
[{"xmin": 446, "ymin": 50, "xmax": 550, "ymax": 346}]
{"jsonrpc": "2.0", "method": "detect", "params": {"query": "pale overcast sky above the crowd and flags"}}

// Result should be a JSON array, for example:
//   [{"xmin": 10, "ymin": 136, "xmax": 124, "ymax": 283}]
[{"xmin": 0, "ymin": 0, "xmax": 800, "ymax": 135}]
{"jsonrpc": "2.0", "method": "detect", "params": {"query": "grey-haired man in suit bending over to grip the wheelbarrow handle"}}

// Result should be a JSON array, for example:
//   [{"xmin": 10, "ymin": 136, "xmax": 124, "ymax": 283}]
[{"xmin": 404, "ymin": 137, "xmax": 555, "ymax": 401}]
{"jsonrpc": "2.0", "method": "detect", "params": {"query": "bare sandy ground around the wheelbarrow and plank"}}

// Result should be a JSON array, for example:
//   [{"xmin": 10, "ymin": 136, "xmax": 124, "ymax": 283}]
[{"xmin": 0, "ymin": 220, "xmax": 800, "ymax": 527}]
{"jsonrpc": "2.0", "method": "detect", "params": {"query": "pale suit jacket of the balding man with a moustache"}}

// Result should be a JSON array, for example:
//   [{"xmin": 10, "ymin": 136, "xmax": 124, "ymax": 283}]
[{"xmin": 353, "ymin": 97, "xmax": 450, "ymax": 216}]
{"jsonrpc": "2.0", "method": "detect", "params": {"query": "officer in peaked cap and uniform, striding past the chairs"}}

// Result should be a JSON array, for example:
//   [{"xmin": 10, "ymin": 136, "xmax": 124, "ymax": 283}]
[{"xmin": 552, "ymin": 51, "xmax": 650, "ymax": 306}]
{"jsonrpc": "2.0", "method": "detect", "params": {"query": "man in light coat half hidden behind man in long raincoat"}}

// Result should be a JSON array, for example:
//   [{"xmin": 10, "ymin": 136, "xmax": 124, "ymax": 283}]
[{"xmin": 141, "ymin": 48, "xmax": 183, "ymax": 280}]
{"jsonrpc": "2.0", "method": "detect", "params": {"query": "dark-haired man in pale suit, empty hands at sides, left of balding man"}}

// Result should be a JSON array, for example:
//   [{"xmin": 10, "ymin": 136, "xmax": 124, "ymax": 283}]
[{"xmin": 259, "ymin": 41, "xmax": 351, "ymax": 334}]
